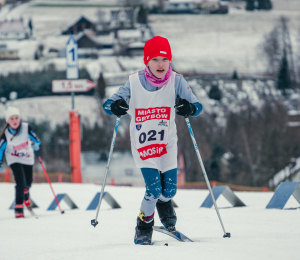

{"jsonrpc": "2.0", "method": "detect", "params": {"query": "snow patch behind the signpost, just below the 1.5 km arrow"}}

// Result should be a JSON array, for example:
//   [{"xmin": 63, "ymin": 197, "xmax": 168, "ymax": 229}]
[{"xmin": 0, "ymin": 95, "xmax": 102, "ymax": 128}]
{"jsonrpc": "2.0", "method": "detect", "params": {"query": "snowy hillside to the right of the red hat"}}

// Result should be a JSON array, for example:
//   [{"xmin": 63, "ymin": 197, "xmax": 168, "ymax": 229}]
[{"xmin": 150, "ymin": 0, "xmax": 300, "ymax": 74}]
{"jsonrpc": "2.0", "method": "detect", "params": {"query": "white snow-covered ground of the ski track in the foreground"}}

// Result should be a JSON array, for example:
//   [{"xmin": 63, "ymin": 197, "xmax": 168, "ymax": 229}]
[{"xmin": 0, "ymin": 183, "xmax": 300, "ymax": 260}]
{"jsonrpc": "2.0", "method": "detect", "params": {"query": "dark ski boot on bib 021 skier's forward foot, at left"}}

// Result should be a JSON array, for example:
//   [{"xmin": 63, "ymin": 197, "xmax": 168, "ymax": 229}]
[{"xmin": 134, "ymin": 212, "xmax": 154, "ymax": 245}]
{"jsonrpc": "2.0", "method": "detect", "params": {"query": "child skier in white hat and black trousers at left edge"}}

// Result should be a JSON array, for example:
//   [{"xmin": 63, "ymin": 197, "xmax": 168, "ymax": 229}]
[{"xmin": 0, "ymin": 107, "xmax": 41, "ymax": 218}]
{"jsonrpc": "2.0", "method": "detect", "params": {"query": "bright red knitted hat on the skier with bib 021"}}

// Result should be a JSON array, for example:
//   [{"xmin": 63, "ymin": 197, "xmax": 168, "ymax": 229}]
[{"xmin": 144, "ymin": 36, "xmax": 172, "ymax": 66}]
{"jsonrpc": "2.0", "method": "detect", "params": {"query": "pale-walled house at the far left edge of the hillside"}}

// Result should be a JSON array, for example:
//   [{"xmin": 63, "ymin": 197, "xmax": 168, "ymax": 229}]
[{"xmin": 0, "ymin": 19, "xmax": 29, "ymax": 40}]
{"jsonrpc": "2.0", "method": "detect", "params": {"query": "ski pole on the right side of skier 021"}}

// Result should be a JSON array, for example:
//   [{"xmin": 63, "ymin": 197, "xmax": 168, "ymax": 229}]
[{"xmin": 185, "ymin": 116, "xmax": 230, "ymax": 238}]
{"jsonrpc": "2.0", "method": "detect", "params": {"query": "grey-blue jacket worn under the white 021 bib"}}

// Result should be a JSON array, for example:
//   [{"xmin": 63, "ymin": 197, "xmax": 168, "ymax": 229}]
[{"xmin": 103, "ymin": 71, "xmax": 202, "ymax": 117}]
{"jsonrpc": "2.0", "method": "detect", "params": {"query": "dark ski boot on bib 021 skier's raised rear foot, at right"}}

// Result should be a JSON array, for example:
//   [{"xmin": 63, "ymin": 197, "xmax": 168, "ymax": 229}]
[{"xmin": 156, "ymin": 200, "xmax": 177, "ymax": 232}]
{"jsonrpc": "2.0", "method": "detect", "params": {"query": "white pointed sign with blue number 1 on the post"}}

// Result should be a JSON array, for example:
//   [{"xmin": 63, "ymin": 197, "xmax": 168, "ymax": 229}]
[{"xmin": 66, "ymin": 35, "xmax": 78, "ymax": 79}]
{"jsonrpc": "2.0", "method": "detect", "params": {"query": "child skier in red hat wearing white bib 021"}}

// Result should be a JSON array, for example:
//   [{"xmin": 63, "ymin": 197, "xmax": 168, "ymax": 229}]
[{"xmin": 103, "ymin": 36, "xmax": 202, "ymax": 245}]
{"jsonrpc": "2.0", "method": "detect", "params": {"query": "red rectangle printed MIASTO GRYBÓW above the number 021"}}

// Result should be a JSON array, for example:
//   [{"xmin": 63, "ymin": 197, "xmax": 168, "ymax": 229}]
[{"xmin": 135, "ymin": 107, "xmax": 171, "ymax": 123}]
